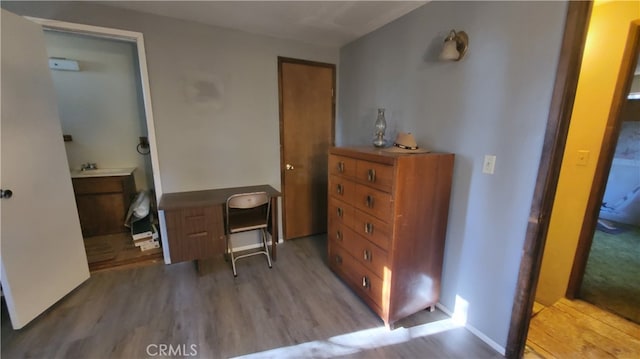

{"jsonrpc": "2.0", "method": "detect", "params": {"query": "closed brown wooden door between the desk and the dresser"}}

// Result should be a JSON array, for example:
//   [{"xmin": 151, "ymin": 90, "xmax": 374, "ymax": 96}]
[{"xmin": 278, "ymin": 58, "xmax": 335, "ymax": 239}]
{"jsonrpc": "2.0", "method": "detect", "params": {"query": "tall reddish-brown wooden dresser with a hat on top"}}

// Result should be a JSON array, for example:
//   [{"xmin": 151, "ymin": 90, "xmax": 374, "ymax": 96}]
[{"xmin": 327, "ymin": 147, "xmax": 454, "ymax": 327}]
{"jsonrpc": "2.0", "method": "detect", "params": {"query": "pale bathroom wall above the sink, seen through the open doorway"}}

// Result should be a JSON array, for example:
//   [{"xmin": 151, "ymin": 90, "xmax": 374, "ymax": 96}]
[{"xmin": 45, "ymin": 31, "xmax": 153, "ymax": 190}]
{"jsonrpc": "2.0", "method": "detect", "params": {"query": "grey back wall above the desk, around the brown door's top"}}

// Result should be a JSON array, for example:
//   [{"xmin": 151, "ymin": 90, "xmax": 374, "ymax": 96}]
[{"xmin": 2, "ymin": 1, "xmax": 339, "ymax": 193}]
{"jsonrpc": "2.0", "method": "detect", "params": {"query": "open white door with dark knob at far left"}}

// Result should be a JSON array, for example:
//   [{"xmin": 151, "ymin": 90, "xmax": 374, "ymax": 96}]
[{"xmin": 0, "ymin": 10, "xmax": 89, "ymax": 329}]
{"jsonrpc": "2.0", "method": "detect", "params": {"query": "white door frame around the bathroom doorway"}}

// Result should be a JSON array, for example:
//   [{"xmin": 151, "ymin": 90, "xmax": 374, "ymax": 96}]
[{"xmin": 24, "ymin": 16, "xmax": 169, "ymax": 263}]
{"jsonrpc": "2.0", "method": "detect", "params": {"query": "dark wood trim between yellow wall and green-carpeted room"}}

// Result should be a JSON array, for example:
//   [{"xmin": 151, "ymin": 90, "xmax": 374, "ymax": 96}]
[{"xmin": 566, "ymin": 20, "xmax": 640, "ymax": 299}]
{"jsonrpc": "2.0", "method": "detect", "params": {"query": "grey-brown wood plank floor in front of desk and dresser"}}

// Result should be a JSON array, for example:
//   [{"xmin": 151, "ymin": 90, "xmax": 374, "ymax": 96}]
[{"xmin": 1, "ymin": 236, "xmax": 502, "ymax": 358}]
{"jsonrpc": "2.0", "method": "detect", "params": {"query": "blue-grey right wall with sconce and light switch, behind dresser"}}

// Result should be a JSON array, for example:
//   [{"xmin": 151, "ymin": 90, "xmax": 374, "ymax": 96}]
[{"xmin": 336, "ymin": 2, "xmax": 566, "ymax": 347}]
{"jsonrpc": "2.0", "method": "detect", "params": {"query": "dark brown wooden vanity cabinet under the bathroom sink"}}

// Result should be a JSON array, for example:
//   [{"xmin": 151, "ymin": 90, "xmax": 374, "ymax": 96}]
[{"xmin": 71, "ymin": 175, "xmax": 136, "ymax": 237}]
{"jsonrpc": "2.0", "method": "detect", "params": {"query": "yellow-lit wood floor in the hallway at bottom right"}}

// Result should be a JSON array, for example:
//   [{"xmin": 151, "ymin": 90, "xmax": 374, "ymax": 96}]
[{"xmin": 525, "ymin": 299, "xmax": 640, "ymax": 359}]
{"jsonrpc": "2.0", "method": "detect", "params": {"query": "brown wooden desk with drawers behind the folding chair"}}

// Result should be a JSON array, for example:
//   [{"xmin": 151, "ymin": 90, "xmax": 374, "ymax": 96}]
[{"xmin": 158, "ymin": 185, "xmax": 282, "ymax": 263}]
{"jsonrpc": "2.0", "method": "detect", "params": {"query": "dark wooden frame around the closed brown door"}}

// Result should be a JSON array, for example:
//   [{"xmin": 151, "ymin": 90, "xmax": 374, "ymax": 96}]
[{"xmin": 278, "ymin": 56, "xmax": 336, "ymax": 240}]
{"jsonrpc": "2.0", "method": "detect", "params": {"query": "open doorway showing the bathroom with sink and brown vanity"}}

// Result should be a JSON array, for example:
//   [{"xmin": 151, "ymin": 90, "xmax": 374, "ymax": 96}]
[{"xmin": 44, "ymin": 28, "xmax": 163, "ymax": 271}]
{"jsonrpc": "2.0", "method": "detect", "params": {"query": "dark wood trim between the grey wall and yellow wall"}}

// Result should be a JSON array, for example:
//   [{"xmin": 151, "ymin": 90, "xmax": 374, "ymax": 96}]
[{"xmin": 505, "ymin": 1, "xmax": 592, "ymax": 358}]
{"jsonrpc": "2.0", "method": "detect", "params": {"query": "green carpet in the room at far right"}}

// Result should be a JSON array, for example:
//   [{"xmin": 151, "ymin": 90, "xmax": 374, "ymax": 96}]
[{"xmin": 580, "ymin": 226, "xmax": 640, "ymax": 323}]
